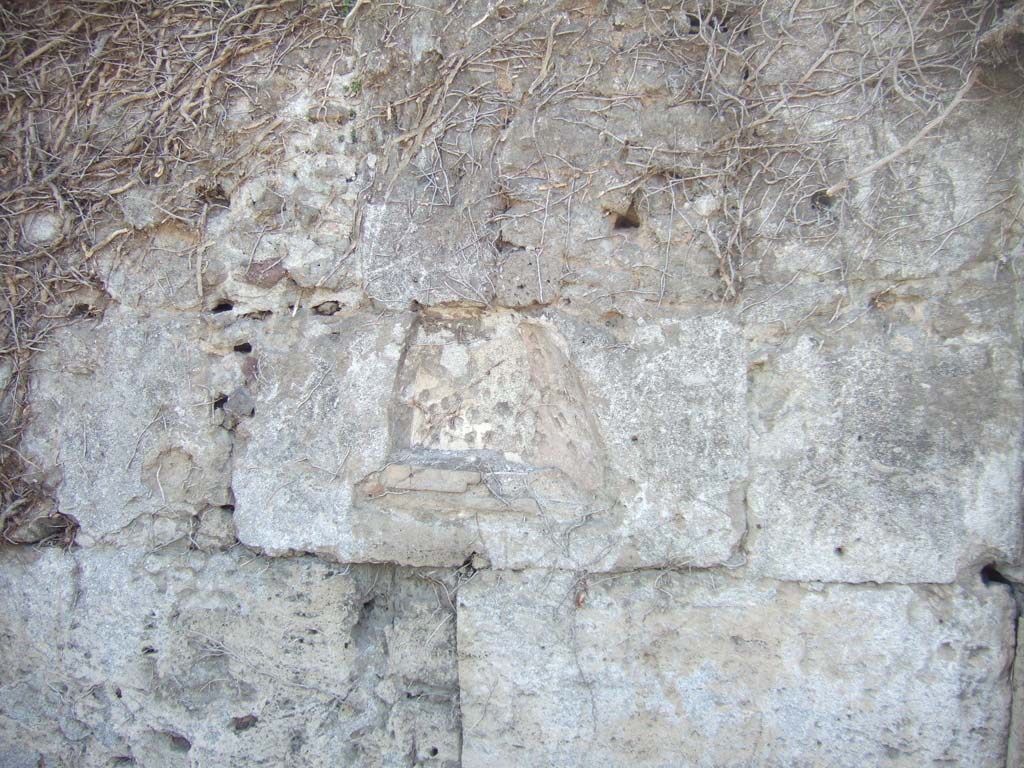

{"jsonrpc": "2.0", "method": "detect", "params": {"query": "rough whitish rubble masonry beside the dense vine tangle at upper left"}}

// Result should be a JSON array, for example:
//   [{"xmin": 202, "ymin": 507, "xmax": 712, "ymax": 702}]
[{"xmin": 96, "ymin": 60, "xmax": 367, "ymax": 313}]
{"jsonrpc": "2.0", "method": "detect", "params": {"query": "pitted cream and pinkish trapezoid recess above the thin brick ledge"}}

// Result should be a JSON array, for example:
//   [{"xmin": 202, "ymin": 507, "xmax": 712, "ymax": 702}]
[{"xmin": 392, "ymin": 308, "xmax": 605, "ymax": 489}]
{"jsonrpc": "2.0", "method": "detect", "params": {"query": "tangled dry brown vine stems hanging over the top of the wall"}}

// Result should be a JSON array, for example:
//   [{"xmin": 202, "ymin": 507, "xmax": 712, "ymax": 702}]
[{"xmin": 0, "ymin": 0, "xmax": 1022, "ymax": 540}]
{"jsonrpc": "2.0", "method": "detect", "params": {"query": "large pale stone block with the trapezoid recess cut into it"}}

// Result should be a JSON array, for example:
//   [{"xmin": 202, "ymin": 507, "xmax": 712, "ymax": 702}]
[{"xmin": 232, "ymin": 306, "xmax": 746, "ymax": 567}]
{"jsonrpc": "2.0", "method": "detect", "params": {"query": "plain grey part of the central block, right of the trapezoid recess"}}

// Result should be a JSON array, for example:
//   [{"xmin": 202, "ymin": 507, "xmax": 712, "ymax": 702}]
[{"xmin": 560, "ymin": 313, "xmax": 748, "ymax": 567}]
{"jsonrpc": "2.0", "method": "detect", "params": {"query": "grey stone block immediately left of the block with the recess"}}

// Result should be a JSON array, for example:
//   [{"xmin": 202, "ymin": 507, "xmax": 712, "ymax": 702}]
[{"xmin": 23, "ymin": 308, "xmax": 231, "ymax": 545}]
